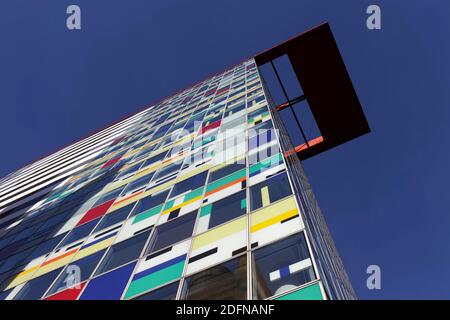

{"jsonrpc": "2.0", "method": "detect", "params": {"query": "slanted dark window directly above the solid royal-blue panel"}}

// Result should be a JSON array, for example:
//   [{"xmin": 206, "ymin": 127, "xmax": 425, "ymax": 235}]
[{"xmin": 96, "ymin": 231, "xmax": 150, "ymax": 275}]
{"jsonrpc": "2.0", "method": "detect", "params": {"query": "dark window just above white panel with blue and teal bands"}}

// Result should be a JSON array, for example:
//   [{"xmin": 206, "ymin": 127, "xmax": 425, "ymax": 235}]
[{"xmin": 147, "ymin": 211, "xmax": 197, "ymax": 253}]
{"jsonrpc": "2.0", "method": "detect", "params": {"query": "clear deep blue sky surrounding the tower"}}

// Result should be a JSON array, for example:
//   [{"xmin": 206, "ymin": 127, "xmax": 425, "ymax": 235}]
[{"xmin": 0, "ymin": 0, "xmax": 450, "ymax": 299}]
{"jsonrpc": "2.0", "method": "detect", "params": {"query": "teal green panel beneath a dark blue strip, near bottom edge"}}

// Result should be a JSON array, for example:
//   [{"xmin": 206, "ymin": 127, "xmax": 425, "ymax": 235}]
[{"xmin": 125, "ymin": 261, "xmax": 184, "ymax": 299}]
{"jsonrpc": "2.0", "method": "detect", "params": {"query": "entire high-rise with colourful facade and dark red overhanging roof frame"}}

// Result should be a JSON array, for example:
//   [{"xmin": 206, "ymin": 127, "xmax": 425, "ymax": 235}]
[{"xmin": 0, "ymin": 24, "xmax": 369, "ymax": 300}]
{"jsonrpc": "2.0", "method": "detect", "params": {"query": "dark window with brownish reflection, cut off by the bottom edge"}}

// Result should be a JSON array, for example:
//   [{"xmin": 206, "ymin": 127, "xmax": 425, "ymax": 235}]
[{"xmin": 181, "ymin": 255, "xmax": 247, "ymax": 300}]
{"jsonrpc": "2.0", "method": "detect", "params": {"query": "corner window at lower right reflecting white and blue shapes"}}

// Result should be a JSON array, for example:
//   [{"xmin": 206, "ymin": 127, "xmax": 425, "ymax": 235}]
[{"xmin": 252, "ymin": 233, "xmax": 316, "ymax": 299}]
